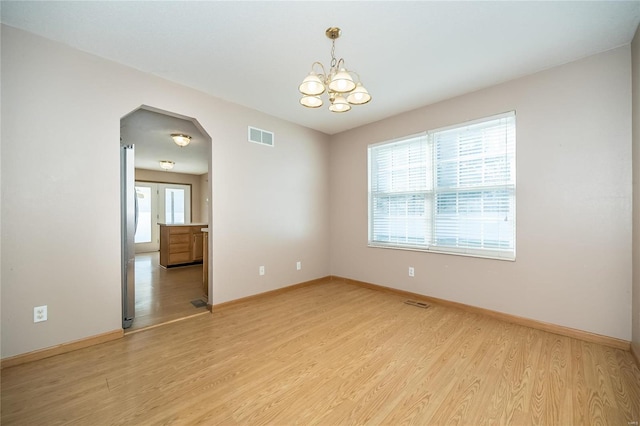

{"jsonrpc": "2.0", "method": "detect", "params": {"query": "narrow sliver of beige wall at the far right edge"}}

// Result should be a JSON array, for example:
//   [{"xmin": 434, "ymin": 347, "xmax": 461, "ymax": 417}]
[{"xmin": 631, "ymin": 27, "xmax": 640, "ymax": 354}]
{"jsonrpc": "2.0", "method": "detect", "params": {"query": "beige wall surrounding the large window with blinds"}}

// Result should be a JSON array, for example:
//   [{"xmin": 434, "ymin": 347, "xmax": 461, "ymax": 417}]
[{"xmin": 330, "ymin": 46, "xmax": 631, "ymax": 340}]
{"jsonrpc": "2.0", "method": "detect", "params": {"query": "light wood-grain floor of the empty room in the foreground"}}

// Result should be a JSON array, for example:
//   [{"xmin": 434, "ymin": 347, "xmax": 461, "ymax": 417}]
[{"xmin": 1, "ymin": 281, "xmax": 640, "ymax": 426}]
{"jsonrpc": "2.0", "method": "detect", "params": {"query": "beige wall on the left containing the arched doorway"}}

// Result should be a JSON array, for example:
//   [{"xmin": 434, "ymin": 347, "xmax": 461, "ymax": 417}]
[{"xmin": 0, "ymin": 26, "xmax": 330, "ymax": 358}]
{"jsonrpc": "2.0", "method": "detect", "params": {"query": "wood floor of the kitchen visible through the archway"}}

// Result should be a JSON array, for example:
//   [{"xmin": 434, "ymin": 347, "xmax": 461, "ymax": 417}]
[{"xmin": 126, "ymin": 252, "xmax": 207, "ymax": 332}]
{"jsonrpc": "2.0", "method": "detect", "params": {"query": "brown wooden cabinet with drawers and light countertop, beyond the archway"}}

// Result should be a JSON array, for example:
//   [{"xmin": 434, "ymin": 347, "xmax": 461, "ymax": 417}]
[{"xmin": 160, "ymin": 224, "xmax": 203, "ymax": 268}]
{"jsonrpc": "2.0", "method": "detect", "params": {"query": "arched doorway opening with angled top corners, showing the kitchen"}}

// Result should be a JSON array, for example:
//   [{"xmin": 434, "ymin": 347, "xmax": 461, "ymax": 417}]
[{"xmin": 120, "ymin": 105, "xmax": 212, "ymax": 331}]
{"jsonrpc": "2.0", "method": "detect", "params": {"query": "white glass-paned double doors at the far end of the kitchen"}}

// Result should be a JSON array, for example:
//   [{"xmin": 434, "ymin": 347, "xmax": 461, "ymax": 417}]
[{"xmin": 135, "ymin": 181, "xmax": 191, "ymax": 253}]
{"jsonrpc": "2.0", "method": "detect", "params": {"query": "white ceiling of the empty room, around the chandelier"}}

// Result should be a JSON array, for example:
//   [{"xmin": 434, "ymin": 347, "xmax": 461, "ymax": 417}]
[{"xmin": 1, "ymin": 0, "xmax": 640, "ymax": 173}]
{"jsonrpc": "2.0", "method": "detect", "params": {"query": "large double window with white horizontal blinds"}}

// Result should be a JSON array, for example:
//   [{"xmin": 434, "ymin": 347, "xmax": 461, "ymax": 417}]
[{"xmin": 369, "ymin": 112, "xmax": 516, "ymax": 260}]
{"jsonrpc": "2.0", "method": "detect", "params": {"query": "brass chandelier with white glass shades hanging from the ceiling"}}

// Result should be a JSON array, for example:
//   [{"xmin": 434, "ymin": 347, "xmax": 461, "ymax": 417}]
[{"xmin": 298, "ymin": 27, "xmax": 371, "ymax": 112}]
